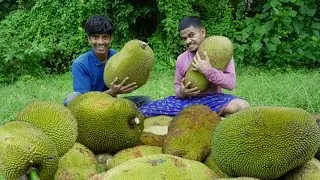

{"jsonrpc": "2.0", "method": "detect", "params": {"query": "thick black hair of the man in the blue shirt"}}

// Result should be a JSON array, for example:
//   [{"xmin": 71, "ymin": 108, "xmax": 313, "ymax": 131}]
[{"xmin": 84, "ymin": 15, "xmax": 113, "ymax": 36}]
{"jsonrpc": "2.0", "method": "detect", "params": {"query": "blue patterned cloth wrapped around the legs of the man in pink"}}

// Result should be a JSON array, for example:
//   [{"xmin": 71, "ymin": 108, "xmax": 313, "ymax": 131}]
[{"xmin": 140, "ymin": 93, "xmax": 237, "ymax": 117}]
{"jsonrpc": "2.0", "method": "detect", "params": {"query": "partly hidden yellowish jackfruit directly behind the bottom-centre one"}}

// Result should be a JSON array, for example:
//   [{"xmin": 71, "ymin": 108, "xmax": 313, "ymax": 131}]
[{"xmin": 107, "ymin": 145, "xmax": 162, "ymax": 169}]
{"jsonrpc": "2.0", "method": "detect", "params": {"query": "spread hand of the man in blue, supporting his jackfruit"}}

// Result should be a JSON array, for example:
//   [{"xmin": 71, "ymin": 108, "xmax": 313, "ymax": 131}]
[{"xmin": 105, "ymin": 77, "xmax": 137, "ymax": 96}]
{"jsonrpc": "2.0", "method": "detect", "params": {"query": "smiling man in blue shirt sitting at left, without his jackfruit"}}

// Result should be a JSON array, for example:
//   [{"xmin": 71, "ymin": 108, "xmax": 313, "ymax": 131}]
[{"xmin": 64, "ymin": 15, "xmax": 151, "ymax": 106}]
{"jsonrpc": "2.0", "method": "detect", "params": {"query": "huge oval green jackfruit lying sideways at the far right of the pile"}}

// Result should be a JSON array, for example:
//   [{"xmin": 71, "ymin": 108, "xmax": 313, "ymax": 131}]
[{"xmin": 212, "ymin": 106, "xmax": 320, "ymax": 179}]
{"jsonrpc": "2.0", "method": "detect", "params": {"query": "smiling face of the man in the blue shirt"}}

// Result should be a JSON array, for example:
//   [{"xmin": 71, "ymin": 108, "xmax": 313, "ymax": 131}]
[{"xmin": 88, "ymin": 34, "xmax": 112, "ymax": 56}]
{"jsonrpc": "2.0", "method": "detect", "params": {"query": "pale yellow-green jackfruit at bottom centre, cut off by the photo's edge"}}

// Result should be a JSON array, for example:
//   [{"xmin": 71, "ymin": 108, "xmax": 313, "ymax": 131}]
[{"xmin": 90, "ymin": 154, "xmax": 217, "ymax": 180}]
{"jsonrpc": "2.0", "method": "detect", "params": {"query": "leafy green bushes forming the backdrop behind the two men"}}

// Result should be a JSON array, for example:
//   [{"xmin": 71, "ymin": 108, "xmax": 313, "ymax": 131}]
[{"xmin": 0, "ymin": 0, "xmax": 320, "ymax": 83}]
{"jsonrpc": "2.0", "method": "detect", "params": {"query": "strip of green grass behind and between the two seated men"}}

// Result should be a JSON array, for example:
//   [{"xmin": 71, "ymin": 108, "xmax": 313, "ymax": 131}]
[{"xmin": 0, "ymin": 68, "xmax": 320, "ymax": 124}]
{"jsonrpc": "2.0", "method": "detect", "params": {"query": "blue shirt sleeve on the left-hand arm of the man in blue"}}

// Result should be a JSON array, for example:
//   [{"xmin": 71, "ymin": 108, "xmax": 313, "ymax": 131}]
[{"xmin": 71, "ymin": 63, "xmax": 91, "ymax": 94}]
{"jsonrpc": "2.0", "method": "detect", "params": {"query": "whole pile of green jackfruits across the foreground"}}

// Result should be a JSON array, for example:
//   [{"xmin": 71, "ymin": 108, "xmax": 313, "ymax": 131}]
[{"xmin": 0, "ymin": 92, "xmax": 320, "ymax": 180}]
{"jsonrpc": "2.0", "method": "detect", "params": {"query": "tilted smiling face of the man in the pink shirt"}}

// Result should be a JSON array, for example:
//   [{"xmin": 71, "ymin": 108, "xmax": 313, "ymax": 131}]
[{"xmin": 180, "ymin": 26, "xmax": 206, "ymax": 53}]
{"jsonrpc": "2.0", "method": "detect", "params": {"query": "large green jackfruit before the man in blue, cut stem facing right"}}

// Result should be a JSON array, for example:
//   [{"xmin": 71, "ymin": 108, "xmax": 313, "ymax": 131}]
[{"xmin": 68, "ymin": 91, "xmax": 144, "ymax": 154}]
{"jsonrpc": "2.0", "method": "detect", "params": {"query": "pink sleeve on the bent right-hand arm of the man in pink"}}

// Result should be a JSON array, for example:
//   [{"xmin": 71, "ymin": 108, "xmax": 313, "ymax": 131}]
[{"xmin": 204, "ymin": 58, "xmax": 236, "ymax": 90}]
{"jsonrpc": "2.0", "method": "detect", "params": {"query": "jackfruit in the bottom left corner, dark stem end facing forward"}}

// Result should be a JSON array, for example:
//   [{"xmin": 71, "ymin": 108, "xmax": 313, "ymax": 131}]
[{"xmin": 0, "ymin": 121, "xmax": 59, "ymax": 180}]
